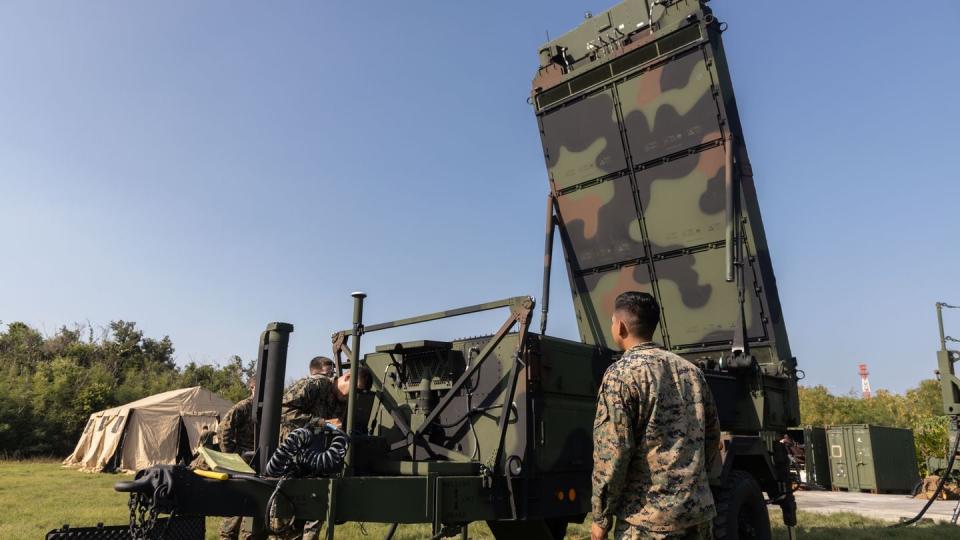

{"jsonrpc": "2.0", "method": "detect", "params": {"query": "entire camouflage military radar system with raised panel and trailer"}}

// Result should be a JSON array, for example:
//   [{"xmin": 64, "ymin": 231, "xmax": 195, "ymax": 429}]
[{"xmin": 65, "ymin": 0, "xmax": 799, "ymax": 540}]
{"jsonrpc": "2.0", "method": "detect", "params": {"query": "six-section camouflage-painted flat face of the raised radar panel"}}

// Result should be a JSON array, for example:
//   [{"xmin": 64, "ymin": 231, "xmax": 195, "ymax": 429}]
[{"xmin": 542, "ymin": 44, "xmax": 766, "ymax": 347}]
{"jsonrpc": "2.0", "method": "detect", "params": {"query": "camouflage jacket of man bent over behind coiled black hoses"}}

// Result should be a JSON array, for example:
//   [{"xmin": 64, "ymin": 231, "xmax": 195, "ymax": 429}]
[{"xmin": 280, "ymin": 375, "xmax": 346, "ymax": 434}]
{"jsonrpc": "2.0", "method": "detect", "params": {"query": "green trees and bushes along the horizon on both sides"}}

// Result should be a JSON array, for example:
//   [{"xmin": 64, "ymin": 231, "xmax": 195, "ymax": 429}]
[{"xmin": 0, "ymin": 321, "xmax": 947, "ymax": 470}]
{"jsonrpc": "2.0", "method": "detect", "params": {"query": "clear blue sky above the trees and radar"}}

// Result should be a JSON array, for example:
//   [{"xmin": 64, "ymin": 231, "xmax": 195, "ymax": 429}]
[{"xmin": 0, "ymin": 0, "xmax": 960, "ymax": 392}]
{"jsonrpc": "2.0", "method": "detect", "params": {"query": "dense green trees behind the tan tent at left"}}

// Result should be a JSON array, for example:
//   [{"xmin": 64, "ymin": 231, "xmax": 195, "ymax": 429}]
[{"xmin": 0, "ymin": 321, "xmax": 253, "ymax": 458}]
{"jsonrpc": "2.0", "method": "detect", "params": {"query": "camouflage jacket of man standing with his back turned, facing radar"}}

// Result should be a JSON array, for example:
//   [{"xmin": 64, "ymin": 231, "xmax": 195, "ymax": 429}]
[{"xmin": 592, "ymin": 344, "xmax": 720, "ymax": 532}]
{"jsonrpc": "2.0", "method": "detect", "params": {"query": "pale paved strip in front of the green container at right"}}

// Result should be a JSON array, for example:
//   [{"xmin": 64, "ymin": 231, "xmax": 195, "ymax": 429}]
[{"xmin": 795, "ymin": 491, "xmax": 957, "ymax": 521}]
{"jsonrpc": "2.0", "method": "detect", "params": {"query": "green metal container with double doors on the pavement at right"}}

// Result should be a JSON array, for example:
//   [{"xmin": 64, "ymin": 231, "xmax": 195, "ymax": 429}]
[{"xmin": 827, "ymin": 424, "xmax": 920, "ymax": 493}]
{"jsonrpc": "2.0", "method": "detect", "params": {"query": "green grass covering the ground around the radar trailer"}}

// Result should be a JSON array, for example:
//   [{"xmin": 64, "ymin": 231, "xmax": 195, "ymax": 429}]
[{"xmin": 0, "ymin": 461, "xmax": 960, "ymax": 540}]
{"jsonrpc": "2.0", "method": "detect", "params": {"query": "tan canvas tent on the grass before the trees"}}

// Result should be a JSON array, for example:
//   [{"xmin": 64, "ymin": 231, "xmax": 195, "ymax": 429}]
[{"xmin": 63, "ymin": 386, "xmax": 233, "ymax": 471}]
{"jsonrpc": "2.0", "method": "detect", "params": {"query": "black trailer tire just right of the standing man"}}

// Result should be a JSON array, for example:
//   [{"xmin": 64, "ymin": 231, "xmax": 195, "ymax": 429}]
[{"xmin": 713, "ymin": 470, "xmax": 771, "ymax": 540}]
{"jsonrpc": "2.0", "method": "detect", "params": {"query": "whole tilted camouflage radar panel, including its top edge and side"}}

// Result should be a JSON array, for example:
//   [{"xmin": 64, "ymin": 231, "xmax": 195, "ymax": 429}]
[{"xmin": 532, "ymin": 0, "xmax": 792, "ymax": 378}]
